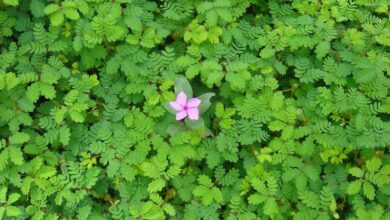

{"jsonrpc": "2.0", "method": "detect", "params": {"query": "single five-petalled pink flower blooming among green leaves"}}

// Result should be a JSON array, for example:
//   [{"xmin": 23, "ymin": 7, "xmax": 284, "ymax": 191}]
[{"xmin": 169, "ymin": 92, "xmax": 201, "ymax": 121}]
